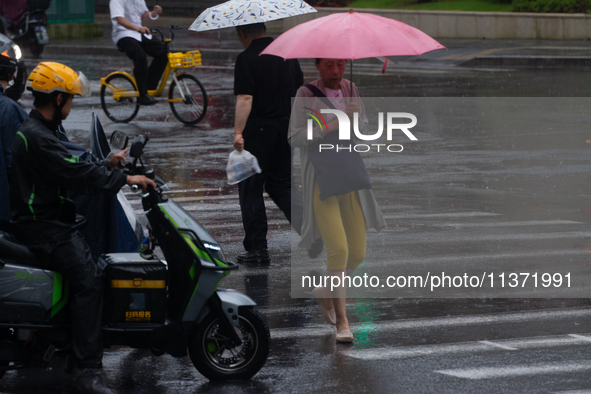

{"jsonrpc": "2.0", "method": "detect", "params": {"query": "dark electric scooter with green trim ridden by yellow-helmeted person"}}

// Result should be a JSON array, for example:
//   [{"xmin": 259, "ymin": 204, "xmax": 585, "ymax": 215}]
[{"xmin": 0, "ymin": 132, "xmax": 270, "ymax": 380}]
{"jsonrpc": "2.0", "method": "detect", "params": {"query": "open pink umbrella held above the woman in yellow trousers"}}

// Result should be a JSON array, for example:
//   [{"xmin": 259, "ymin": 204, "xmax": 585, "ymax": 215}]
[{"xmin": 261, "ymin": 10, "xmax": 445, "ymax": 87}]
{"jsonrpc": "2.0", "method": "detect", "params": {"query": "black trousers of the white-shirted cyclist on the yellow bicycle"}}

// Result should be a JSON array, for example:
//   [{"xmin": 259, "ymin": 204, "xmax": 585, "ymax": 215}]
[{"xmin": 117, "ymin": 34, "xmax": 168, "ymax": 95}]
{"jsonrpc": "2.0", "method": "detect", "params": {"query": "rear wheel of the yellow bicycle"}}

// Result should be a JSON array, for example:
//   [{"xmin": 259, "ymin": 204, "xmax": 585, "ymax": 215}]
[{"xmin": 101, "ymin": 74, "xmax": 140, "ymax": 123}]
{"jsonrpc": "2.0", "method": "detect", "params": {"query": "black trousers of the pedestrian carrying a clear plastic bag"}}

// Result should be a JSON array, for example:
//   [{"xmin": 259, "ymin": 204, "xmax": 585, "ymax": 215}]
[{"xmin": 238, "ymin": 117, "xmax": 291, "ymax": 251}]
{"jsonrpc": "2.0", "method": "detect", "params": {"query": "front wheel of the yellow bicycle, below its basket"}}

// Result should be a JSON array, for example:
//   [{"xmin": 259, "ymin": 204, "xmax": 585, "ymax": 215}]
[{"xmin": 168, "ymin": 74, "xmax": 207, "ymax": 125}]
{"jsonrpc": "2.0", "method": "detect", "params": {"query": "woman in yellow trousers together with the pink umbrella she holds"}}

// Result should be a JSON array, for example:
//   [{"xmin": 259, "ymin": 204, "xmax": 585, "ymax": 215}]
[{"xmin": 272, "ymin": 10, "xmax": 444, "ymax": 342}]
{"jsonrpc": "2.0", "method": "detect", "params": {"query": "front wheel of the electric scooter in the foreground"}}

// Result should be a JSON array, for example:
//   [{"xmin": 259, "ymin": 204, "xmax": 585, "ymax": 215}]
[{"xmin": 188, "ymin": 308, "xmax": 271, "ymax": 380}]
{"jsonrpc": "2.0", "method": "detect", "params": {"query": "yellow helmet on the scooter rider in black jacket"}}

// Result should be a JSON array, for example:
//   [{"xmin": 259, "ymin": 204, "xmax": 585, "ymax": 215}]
[{"xmin": 27, "ymin": 62, "xmax": 90, "ymax": 97}]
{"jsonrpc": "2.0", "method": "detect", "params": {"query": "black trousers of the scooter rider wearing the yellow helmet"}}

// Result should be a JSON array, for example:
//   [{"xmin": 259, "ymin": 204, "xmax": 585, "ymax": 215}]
[{"xmin": 26, "ymin": 230, "xmax": 103, "ymax": 368}]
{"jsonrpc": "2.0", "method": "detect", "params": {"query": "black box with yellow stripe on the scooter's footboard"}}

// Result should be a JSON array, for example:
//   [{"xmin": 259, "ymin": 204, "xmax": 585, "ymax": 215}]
[{"xmin": 100, "ymin": 253, "xmax": 168, "ymax": 324}]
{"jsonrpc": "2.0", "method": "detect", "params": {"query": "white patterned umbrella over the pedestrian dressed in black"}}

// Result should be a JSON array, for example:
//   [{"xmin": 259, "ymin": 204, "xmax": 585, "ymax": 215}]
[{"xmin": 189, "ymin": 0, "xmax": 317, "ymax": 31}]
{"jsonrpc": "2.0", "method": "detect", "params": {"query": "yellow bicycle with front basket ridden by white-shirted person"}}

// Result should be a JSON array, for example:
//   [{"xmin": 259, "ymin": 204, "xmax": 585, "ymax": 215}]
[{"xmin": 101, "ymin": 26, "xmax": 207, "ymax": 125}]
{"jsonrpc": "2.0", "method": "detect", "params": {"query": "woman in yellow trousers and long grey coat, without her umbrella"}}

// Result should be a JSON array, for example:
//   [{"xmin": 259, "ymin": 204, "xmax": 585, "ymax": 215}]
[{"xmin": 289, "ymin": 59, "xmax": 386, "ymax": 342}]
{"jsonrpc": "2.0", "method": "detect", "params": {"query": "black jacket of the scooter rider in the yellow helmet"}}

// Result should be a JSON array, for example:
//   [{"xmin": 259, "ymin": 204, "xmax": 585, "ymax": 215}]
[{"xmin": 10, "ymin": 110, "xmax": 127, "ymax": 244}]
